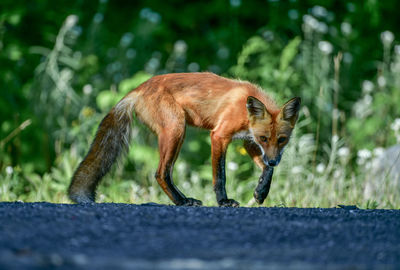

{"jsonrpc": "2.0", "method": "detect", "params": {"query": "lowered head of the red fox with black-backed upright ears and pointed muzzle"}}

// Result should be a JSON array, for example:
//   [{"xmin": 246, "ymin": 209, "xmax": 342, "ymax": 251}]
[{"xmin": 246, "ymin": 96, "xmax": 301, "ymax": 166}]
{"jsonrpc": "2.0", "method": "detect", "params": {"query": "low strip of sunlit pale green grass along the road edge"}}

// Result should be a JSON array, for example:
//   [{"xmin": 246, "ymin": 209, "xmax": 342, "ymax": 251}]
[{"xmin": 0, "ymin": 129, "xmax": 400, "ymax": 209}]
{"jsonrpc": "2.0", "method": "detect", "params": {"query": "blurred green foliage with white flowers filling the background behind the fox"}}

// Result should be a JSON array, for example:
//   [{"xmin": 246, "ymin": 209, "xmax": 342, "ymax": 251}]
[{"xmin": 0, "ymin": 0, "xmax": 400, "ymax": 207}]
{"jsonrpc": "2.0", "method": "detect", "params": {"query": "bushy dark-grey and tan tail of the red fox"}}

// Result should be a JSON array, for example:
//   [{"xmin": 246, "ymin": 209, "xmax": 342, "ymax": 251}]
[{"xmin": 68, "ymin": 96, "xmax": 134, "ymax": 203}]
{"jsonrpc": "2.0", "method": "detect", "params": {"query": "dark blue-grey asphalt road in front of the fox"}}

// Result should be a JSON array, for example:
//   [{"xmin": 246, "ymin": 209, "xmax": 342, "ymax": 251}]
[{"xmin": 0, "ymin": 203, "xmax": 400, "ymax": 269}]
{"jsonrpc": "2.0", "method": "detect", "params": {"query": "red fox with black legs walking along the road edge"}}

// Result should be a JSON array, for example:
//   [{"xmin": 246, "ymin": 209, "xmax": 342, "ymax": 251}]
[{"xmin": 68, "ymin": 73, "xmax": 301, "ymax": 207}]
